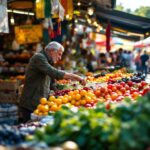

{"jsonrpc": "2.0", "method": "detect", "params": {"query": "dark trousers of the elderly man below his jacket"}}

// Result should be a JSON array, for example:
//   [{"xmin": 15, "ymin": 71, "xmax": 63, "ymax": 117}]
[{"xmin": 19, "ymin": 107, "xmax": 32, "ymax": 123}]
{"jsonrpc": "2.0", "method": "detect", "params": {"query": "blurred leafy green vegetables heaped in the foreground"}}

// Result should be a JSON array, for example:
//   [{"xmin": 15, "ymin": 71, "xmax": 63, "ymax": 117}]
[{"xmin": 29, "ymin": 93, "xmax": 150, "ymax": 150}]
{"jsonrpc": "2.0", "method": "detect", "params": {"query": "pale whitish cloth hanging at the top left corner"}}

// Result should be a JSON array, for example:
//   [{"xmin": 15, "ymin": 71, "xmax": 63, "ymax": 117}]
[{"xmin": 0, "ymin": 0, "xmax": 9, "ymax": 33}]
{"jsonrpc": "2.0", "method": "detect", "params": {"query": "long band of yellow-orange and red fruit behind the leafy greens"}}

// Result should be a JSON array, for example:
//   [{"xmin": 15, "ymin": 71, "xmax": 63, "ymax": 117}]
[{"xmin": 34, "ymin": 74, "xmax": 150, "ymax": 116}]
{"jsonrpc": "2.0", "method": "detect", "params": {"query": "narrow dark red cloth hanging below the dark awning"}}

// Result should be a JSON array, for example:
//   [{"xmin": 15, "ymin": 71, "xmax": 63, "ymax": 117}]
[{"xmin": 106, "ymin": 22, "xmax": 111, "ymax": 52}]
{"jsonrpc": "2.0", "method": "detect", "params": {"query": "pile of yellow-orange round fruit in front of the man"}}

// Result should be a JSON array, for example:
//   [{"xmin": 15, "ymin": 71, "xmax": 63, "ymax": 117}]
[{"xmin": 34, "ymin": 89, "xmax": 97, "ymax": 116}]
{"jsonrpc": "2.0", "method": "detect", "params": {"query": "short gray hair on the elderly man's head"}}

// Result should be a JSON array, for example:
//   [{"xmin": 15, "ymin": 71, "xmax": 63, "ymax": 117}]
[{"xmin": 45, "ymin": 41, "xmax": 64, "ymax": 52}]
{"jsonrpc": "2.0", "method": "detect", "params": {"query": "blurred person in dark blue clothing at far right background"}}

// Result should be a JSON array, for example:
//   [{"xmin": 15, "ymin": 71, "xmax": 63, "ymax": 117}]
[{"xmin": 140, "ymin": 51, "xmax": 149, "ymax": 76}]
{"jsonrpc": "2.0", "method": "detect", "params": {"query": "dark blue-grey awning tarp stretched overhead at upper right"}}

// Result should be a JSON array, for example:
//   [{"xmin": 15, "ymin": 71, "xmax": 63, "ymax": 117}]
[{"xmin": 95, "ymin": 6, "xmax": 150, "ymax": 34}]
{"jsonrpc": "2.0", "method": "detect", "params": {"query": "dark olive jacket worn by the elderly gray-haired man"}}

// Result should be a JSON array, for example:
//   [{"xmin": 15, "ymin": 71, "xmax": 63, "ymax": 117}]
[{"xmin": 20, "ymin": 50, "xmax": 65, "ymax": 112}]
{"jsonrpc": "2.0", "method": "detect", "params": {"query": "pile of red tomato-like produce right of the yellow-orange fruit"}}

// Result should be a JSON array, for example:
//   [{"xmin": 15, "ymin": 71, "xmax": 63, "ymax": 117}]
[{"xmin": 94, "ymin": 81, "xmax": 150, "ymax": 102}]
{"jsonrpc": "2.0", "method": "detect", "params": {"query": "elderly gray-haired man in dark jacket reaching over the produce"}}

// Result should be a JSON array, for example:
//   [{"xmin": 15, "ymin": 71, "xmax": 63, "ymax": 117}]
[{"xmin": 20, "ymin": 42, "xmax": 85, "ymax": 122}]
